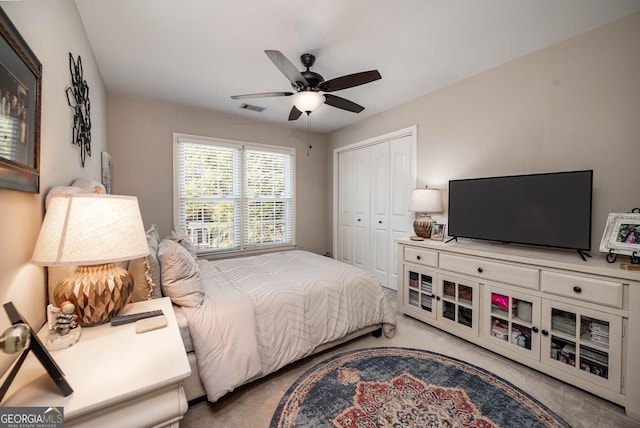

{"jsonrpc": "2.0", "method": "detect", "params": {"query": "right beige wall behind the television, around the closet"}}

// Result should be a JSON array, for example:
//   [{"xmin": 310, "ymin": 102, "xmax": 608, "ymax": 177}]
[{"xmin": 327, "ymin": 13, "xmax": 640, "ymax": 254}]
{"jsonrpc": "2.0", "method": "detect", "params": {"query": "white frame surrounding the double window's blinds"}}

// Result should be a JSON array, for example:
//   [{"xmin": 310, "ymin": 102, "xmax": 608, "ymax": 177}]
[{"xmin": 172, "ymin": 133, "xmax": 297, "ymax": 256}]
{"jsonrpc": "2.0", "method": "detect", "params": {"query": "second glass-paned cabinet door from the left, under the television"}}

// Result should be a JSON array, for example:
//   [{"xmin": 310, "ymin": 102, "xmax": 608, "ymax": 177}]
[{"xmin": 437, "ymin": 275, "xmax": 480, "ymax": 335}]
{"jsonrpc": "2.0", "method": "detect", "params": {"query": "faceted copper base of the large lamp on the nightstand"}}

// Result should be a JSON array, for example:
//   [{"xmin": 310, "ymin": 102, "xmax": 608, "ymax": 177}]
[{"xmin": 53, "ymin": 263, "xmax": 133, "ymax": 327}]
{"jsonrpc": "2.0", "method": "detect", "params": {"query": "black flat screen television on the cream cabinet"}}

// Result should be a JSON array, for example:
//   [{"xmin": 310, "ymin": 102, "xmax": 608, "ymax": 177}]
[{"xmin": 448, "ymin": 170, "xmax": 593, "ymax": 258}]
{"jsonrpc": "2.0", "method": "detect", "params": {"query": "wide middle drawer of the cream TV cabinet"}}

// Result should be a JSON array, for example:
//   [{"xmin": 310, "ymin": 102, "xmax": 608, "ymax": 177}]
[{"xmin": 440, "ymin": 254, "xmax": 538, "ymax": 290}]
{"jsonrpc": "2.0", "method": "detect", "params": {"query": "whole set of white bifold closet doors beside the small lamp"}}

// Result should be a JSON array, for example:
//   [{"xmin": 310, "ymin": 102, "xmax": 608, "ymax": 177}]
[{"xmin": 337, "ymin": 136, "xmax": 415, "ymax": 289}]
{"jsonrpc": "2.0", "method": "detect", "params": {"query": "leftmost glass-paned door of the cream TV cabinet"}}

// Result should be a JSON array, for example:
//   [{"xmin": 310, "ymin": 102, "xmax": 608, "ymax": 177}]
[{"xmin": 404, "ymin": 265, "xmax": 436, "ymax": 318}]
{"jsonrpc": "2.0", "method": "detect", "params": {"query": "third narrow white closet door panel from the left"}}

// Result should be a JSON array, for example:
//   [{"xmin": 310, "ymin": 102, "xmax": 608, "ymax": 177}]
[{"xmin": 370, "ymin": 141, "xmax": 395, "ymax": 287}]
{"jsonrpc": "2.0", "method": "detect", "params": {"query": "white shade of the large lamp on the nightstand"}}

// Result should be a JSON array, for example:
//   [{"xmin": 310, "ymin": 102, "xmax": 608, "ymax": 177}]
[{"xmin": 32, "ymin": 193, "xmax": 149, "ymax": 266}]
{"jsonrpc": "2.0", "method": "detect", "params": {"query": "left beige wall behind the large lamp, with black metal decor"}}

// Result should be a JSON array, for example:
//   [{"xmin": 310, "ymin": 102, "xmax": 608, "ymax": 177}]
[{"xmin": 0, "ymin": 0, "xmax": 107, "ymax": 373}]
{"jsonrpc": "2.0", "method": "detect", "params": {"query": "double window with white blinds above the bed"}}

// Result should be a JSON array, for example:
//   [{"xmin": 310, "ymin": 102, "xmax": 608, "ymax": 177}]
[{"xmin": 174, "ymin": 135, "xmax": 295, "ymax": 252}]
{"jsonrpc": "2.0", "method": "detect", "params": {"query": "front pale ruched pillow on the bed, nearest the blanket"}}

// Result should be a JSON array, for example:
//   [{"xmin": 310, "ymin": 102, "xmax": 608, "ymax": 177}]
[{"xmin": 158, "ymin": 239, "xmax": 204, "ymax": 308}]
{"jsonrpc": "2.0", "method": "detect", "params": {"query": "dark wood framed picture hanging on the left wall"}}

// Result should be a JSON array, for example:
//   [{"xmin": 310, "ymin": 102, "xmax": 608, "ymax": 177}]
[{"xmin": 0, "ymin": 8, "xmax": 42, "ymax": 193}]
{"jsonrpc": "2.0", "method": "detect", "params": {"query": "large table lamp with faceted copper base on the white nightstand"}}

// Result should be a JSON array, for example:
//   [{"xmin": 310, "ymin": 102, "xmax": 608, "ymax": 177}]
[{"xmin": 32, "ymin": 193, "xmax": 149, "ymax": 327}]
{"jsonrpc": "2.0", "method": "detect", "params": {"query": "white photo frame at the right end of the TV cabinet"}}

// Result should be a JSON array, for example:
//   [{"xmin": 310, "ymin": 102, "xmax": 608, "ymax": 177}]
[{"xmin": 600, "ymin": 213, "xmax": 640, "ymax": 257}]
